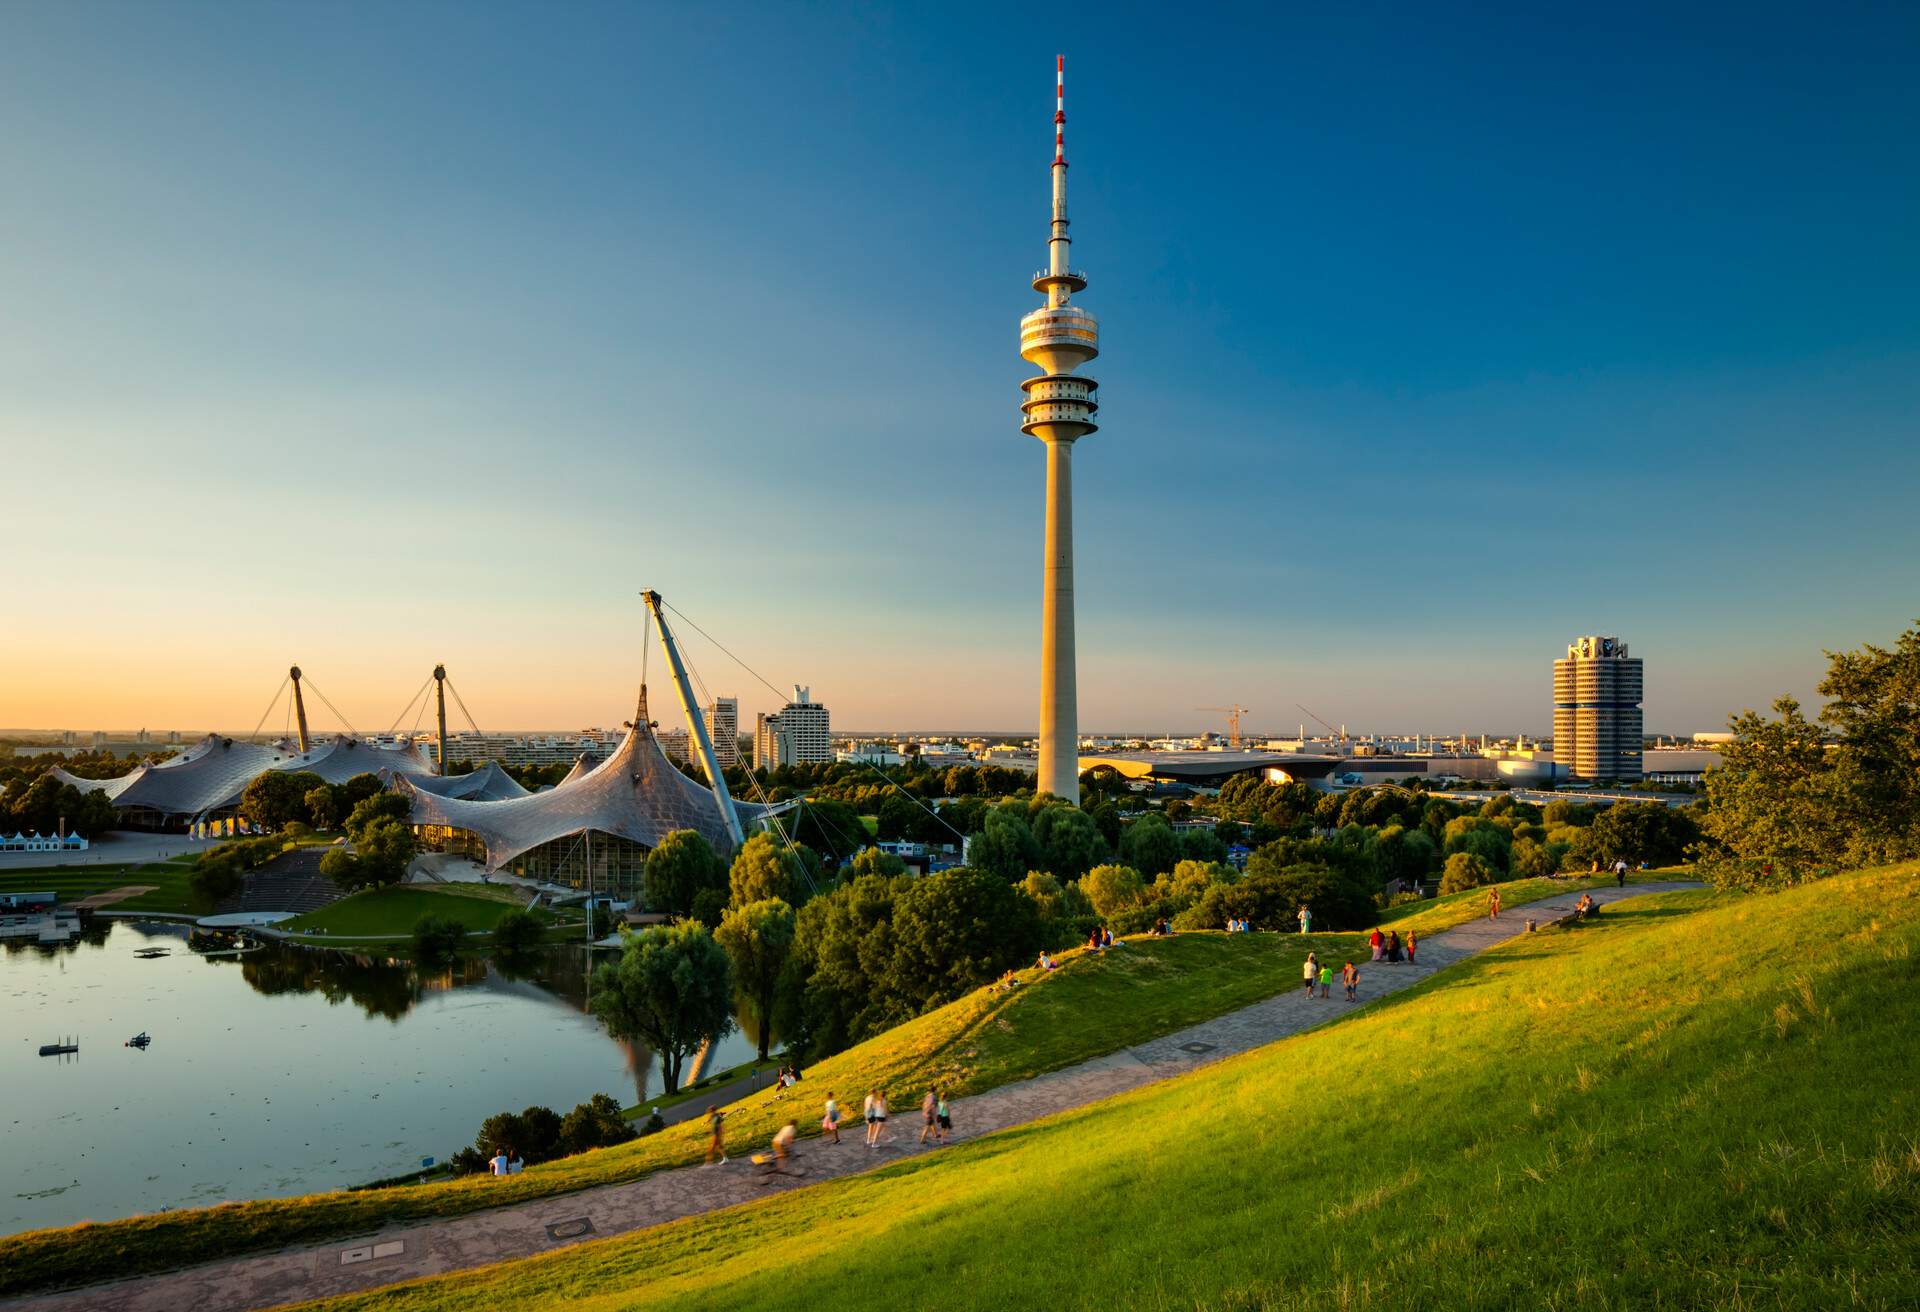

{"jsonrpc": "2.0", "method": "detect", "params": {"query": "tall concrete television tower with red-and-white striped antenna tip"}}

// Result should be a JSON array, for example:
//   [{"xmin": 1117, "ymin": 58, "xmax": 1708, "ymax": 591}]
[{"xmin": 1020, "ymin": 56, "xmax": 1100, "ymax": 803}]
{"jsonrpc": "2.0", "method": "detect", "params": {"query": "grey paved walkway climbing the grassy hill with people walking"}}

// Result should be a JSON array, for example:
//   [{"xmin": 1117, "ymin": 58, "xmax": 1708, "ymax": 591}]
[{"xmin": 8, "ymin": 882, "xmax": 1699, "ymax": 1312}]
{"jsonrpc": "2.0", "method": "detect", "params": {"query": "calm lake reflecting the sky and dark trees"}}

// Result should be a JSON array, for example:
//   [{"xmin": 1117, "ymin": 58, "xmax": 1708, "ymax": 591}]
[{"xmin": 0, "ymin": 920, "xmax": 753, "ymax": 1233}]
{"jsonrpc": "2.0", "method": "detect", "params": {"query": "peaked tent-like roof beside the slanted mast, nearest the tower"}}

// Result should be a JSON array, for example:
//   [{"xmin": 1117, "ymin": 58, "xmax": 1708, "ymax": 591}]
[{"xmin": 396, "ymin": 701, "xmax": 764, "ymax": 870}]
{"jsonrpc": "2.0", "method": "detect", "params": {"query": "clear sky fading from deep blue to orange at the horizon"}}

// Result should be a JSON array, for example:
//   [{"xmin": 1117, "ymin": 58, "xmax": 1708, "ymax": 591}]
[{"xmin": 0, "ymin": 0, "xmax": 1920, "ymax": 734}]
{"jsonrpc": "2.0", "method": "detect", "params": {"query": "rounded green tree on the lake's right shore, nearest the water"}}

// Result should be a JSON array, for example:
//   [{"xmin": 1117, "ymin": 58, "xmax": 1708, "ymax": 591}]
[{"xmin": 593, "ymin": 920, "xmax": 733, "ymax": 1093}]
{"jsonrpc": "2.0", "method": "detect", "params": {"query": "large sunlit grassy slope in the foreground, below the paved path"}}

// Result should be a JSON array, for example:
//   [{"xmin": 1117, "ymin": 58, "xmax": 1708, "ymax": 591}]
[{"xmin": 305, "ymin": 866, "xmax": 1920, "ymax": 1312}]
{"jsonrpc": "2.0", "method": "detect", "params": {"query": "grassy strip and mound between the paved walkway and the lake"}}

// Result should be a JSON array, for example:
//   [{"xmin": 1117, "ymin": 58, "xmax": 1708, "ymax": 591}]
[{"xmin": 0, "ymin": 929, "xmax": 1359, "ymax": 1297}]
